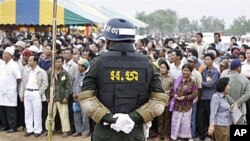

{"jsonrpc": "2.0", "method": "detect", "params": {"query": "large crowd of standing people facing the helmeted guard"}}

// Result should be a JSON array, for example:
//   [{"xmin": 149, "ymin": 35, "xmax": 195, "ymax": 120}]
[{"xmin": 0, "ymin": 29, "xmax": 250, "ymax": 141}]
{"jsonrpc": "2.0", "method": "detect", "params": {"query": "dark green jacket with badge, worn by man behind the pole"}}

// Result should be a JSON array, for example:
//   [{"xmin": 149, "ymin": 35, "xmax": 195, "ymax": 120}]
[{"xmin": 46, "ymin": 69, "xmax": 72, "ymax": 102}]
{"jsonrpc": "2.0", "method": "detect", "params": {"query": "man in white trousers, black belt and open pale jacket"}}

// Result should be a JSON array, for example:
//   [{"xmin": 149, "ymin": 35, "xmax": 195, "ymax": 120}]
[{"xmin": 19, "ymin": 55, "xmax": 48, "ymax": 137}]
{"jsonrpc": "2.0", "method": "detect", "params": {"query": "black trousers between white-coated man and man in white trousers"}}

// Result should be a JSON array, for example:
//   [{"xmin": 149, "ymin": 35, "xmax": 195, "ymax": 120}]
[{"xmin": 17, "ymin": 97, "xmax": 25, "ymax": 127}]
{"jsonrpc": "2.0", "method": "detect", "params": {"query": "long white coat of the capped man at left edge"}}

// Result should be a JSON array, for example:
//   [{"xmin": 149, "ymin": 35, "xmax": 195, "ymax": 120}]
[{"xmin": 0, "ymin": 59, "xmax": 21, "ymax": 106}]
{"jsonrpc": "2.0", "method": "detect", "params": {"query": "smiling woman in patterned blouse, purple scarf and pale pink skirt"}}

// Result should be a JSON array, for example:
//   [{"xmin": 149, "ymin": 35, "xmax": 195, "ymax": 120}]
[{"xmin": 169, "ymin": 64, "xmax": 198, "ymax": 140}]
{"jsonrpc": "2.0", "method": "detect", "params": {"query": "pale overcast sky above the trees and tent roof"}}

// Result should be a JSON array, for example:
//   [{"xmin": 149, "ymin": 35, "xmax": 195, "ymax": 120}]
[{"xmin": 82, "ymin": 0, "xmax": 250, "ymax": 27}]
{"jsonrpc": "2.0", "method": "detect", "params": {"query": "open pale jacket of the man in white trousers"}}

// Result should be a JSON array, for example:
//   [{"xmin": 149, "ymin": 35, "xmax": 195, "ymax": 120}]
[{"xmin": 19, "ymin": 66, "xmax": 48, "ymax": 97}]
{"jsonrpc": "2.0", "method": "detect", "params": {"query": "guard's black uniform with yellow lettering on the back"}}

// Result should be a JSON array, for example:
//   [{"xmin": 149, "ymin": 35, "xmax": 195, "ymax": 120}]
[{"xmin": 82, "ymin": 43, "xmax": 164, "ymax": 141}]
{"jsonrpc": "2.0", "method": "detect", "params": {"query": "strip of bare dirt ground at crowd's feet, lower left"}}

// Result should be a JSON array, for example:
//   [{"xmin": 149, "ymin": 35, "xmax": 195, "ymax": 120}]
[{"xmin": 0, "ymin": 132, "xmax": 91, "ymax": 141}]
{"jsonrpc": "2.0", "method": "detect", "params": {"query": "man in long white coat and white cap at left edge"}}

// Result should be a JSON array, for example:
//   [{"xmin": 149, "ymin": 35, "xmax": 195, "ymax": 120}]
[{"xmin": 0, "ymin": 47, "xmax": 21, "ymax": 133}]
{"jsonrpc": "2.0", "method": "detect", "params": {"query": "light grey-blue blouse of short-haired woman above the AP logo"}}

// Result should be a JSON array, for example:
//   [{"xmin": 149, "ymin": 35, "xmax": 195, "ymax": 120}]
[{"xmin": 210, "ymin": 93, "xmax": 232, "ymax": 126}]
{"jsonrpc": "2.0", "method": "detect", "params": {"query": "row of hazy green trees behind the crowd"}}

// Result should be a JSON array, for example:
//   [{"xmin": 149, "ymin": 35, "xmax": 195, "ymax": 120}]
[{"xmin": 136, "ymin": 9, "xmax": 250, "ymax": 35}]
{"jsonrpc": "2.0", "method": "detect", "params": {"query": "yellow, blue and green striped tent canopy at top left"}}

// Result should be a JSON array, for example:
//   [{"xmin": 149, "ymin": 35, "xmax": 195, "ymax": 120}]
[{"xmin": 0, "ymin": 0, "xmax": 94, "ymax": 25}]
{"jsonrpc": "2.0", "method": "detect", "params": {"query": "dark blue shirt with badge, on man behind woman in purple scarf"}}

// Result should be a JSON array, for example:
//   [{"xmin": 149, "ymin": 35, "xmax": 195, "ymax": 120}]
[{"xmin": 201, "ymin": 67, "xmax": 220, "ymax": 100}]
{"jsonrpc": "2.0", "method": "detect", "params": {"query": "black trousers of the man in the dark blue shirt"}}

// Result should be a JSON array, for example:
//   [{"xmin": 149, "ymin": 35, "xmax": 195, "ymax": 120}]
[{"xmin": 196, "ymin": 100, "xmax": 211, "ymax": 139}]
